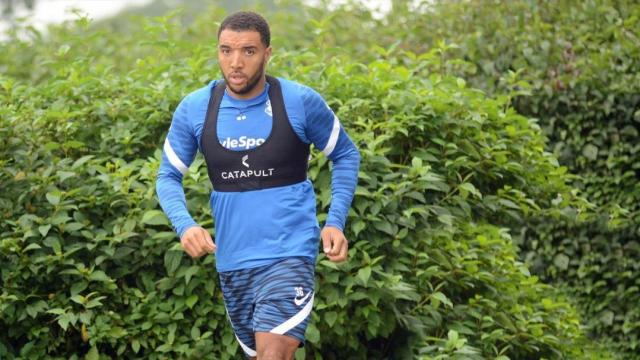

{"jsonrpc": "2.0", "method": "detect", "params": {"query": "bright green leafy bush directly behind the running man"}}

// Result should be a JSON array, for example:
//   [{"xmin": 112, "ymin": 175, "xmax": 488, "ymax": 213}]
[{"xmin": 0, "ymin": 2, "xmax": 610, "ymax": 359}]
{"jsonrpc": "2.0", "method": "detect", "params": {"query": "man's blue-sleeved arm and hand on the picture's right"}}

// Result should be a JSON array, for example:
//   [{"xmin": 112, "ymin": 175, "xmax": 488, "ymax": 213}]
[{"xmin": 303, "ymin": 89, "xmax": 360, "ymax": 262}]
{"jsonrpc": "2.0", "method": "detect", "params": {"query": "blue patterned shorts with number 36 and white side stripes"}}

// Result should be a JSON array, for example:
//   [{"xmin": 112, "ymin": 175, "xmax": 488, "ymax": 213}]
[{"xmin": 219, "ymin": 257, "xmax": 315, "ymax": 356}]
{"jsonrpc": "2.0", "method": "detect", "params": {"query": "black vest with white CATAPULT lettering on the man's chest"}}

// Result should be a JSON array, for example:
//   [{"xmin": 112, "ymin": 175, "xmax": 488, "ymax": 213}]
[{"xmin": 200, "ymin": 75, "xmax": 309, "ymax": 192}]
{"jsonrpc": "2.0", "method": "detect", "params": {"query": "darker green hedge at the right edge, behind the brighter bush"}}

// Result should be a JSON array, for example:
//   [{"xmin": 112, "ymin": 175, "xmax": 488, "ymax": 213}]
[{"xmin": 364, "ymin": 0, "xmax": 640, "ymax": 359}]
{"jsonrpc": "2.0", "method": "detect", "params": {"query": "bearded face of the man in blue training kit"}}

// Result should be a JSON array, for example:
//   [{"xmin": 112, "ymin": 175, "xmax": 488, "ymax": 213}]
[{"xmin": 218, "ymin": 29, "xmax": 271, "ymax": 99}]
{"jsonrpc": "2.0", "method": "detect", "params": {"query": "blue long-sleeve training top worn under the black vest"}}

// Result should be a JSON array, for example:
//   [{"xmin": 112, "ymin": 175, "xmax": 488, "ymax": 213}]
[{"xmin": 156, "ymin": 78, "xmax": 360, "ymax": 272}]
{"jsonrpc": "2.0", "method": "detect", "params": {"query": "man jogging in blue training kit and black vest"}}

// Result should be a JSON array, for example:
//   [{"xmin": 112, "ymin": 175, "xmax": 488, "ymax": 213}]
[{"xmin": 157, "ymin": 12, "xmax": 360, "ymax": 359}]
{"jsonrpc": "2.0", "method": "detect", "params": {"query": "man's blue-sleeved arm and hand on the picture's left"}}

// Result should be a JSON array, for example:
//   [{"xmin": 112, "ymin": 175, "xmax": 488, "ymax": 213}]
[{"xmin": 156, "ymin": 98, "xmax": 215, "ymax": 257}]
